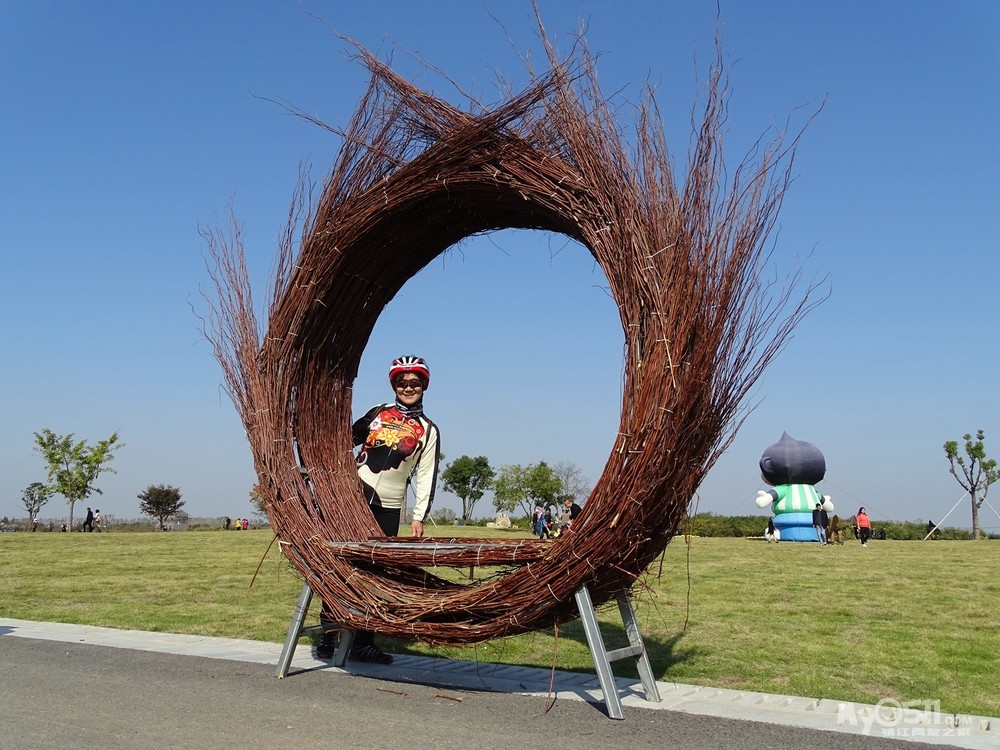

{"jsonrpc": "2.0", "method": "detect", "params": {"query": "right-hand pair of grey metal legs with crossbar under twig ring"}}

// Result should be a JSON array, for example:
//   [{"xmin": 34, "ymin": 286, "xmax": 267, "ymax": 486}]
[{"xmin": 574, "ymin": 586, "xmax": 660, "ymax": 719}]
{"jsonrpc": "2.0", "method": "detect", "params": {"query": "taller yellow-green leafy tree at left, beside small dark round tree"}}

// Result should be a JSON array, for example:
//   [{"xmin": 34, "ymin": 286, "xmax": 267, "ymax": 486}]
[{"xmin": 35, "ymin": 429, "xmax": 124, "ymax": 531}]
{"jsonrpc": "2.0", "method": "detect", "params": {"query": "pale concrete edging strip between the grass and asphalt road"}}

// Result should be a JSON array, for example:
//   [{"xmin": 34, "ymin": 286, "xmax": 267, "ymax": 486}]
[{"xmin": 0, "ymin": 618, "xmax": 1000, "ymax": 750}]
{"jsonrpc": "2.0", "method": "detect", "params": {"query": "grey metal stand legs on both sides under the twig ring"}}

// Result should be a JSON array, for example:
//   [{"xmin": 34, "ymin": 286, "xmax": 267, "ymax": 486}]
[{"xmin": 276, "ymin": 583, "xmax": 660, "ymax": 719}]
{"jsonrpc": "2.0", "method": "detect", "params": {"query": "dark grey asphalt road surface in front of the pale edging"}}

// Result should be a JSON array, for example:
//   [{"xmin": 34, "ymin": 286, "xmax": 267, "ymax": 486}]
[{"xmin": 0, "ymin": 637, "xmax": 968, "ymax": 750}]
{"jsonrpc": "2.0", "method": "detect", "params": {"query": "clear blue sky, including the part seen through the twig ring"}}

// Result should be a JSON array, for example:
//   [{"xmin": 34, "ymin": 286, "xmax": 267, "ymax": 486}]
[{"xmin": 0, "ymin": 0, "xmax": 1000, "ymax": 528}]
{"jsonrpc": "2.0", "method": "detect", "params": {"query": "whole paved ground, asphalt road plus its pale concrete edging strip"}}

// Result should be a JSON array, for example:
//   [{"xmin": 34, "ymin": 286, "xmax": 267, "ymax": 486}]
[{"xmin": 0, "ymin": 618, "xmax": 1000, "ymax": 750}]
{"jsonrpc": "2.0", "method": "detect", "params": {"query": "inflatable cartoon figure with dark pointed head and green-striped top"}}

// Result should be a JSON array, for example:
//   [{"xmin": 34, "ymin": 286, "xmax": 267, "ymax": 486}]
[{"xmin": 757, "ymin": 432, "xmax": 833, "ymax": 542}]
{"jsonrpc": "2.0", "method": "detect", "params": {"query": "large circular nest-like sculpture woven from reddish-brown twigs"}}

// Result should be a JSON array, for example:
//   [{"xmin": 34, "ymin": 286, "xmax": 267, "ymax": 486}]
[{"xmin": 206, "ymin": 35, "xmax": 811, "ymax": 644}]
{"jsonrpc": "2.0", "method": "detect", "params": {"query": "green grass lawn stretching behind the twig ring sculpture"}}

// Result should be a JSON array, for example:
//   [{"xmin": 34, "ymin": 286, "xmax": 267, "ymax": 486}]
[{"xmin": 0, "ymin": 527, "xmax": 1000, "ymax": 716}]
